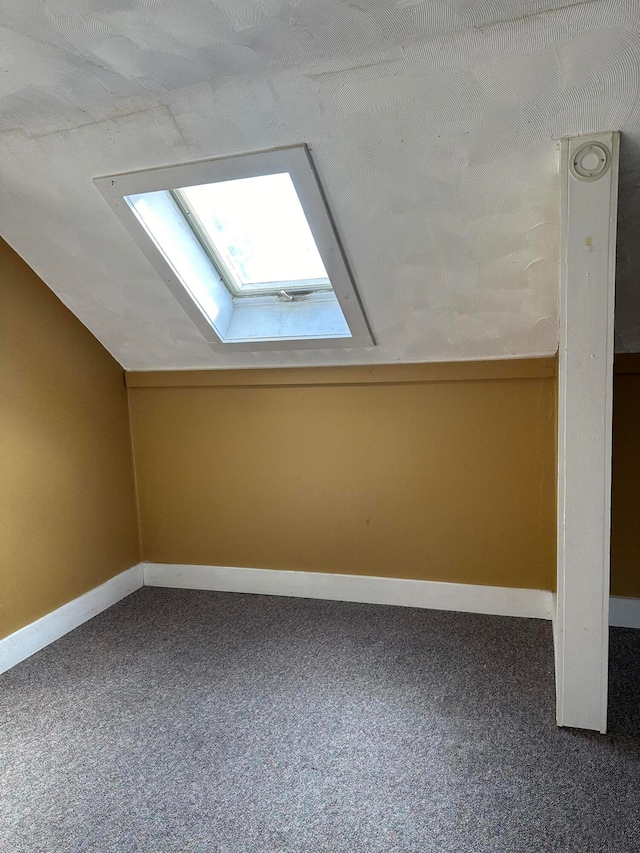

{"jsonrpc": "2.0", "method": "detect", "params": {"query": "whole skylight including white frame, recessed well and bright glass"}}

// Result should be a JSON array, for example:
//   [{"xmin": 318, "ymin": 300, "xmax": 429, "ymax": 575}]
[{"xmin": 96, "ymin": 147, "xmax": 373, "ymax": 350}]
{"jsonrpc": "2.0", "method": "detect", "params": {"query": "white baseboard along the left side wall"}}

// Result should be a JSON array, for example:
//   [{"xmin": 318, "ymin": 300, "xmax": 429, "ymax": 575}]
[{"xmin": 0, "ymin": 563, "xmax": 143, "ymax": 673}]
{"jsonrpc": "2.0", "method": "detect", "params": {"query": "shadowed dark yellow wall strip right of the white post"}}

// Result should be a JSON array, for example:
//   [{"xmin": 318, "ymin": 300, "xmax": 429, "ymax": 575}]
[{"xmin": 611, "ymin": 362, "xmax": 640, "ymax": 598}]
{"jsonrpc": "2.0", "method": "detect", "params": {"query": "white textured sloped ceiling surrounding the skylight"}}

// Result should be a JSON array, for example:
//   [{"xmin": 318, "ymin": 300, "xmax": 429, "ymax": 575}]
[{"xmin": 0, "ymin": 0, "xmax": 640, "ymax": 369}]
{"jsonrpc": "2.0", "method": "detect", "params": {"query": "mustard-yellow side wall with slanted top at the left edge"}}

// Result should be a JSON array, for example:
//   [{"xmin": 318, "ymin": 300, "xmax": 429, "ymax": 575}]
[{"xmin": 0, "ymin": 241, "xmax": 139, "ymax": 637}]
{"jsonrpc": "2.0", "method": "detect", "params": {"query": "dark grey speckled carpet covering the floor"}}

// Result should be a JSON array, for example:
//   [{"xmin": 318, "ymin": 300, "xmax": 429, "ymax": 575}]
[{"xmin": 0, "ymin": 588, "xmax": 640, "ymax": 853}]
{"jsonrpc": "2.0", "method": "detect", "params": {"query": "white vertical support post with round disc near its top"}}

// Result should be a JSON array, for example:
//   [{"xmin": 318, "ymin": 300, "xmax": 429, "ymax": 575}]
[{"xmin": 555, "ymin": 132, "xmax": 619, "ymax": 733}]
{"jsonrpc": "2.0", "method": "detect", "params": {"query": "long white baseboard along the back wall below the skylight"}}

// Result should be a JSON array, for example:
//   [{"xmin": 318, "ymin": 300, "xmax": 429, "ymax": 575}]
[{"xmin": 143, "ymin": 563, "xmax": 551, "ymax": 619}]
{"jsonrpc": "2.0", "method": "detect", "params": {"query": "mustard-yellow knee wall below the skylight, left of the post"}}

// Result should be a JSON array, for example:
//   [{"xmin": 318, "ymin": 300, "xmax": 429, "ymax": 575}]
[{"xmin": 128, "ymin": 359, "xmax": 556, "ymax": 589}]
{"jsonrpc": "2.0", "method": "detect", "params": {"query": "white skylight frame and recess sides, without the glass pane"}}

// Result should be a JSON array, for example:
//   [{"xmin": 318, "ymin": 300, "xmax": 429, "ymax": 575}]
[{"xmin": 95, "ymin": 145, "xmax": 374, "ymax": 352}]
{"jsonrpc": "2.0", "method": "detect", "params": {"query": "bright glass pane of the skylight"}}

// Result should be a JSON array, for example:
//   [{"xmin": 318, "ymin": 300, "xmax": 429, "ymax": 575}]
[{"xmin": 180, "ymin": 172, "xmax": 330, "ymax": 292}]
